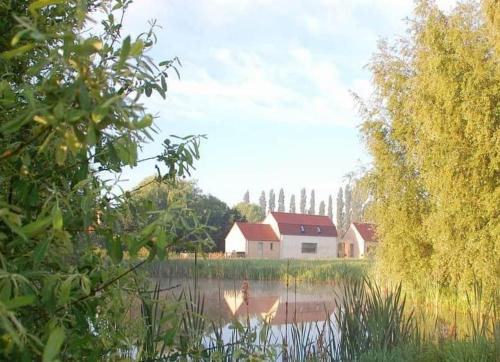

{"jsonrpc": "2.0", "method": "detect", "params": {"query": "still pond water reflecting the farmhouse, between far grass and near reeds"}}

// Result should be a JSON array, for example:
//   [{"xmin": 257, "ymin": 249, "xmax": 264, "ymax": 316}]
[{"xmin": 158, "ymin": 278, "xmax": 339, "ymax": 343}]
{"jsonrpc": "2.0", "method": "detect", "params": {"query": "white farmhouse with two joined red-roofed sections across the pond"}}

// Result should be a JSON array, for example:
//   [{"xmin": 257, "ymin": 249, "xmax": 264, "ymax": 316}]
[{"xmin": 226, "ymin": 212, "xmax": 337, "ymax": 259}]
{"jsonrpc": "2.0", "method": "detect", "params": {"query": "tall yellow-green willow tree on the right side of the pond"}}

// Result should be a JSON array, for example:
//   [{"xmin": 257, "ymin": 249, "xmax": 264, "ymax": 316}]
[{"xmin": 361, "ymin": 1, "xmax": 500, "ymax": 288}]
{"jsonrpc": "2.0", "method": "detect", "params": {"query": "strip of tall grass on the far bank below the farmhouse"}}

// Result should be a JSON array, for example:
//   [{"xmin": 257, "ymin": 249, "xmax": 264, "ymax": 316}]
[{"xmin": 149, "ymin": 258, "xmax": 370, "ymax": 282}]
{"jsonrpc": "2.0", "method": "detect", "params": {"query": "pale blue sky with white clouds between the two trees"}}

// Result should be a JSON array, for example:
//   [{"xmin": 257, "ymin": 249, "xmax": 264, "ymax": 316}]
[{"xmin": 104, "ymin": 0, "xmax": 453, "ymax": 208}]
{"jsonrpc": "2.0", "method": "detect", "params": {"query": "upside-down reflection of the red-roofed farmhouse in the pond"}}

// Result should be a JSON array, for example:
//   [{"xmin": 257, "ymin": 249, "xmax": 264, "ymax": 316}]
[{"xmin": 224, "ymin": 291, "xmax": 331, "ymax": 324}]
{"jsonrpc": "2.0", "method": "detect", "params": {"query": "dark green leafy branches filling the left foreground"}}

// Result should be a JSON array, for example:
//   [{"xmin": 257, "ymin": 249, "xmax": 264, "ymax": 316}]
[{"xmin": 0, "ymin": 0, "xmax": 204, "ymax": 361}]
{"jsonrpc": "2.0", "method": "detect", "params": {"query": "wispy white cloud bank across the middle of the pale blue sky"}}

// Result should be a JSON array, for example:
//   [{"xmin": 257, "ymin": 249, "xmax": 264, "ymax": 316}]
[{"xmin": 154, "ymin": 47, "xmax": 366, "ymax": 127}]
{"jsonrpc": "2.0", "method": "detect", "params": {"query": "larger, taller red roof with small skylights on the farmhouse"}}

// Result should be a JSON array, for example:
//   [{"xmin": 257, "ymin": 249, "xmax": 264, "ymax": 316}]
[{"xmin": 271, "ymin": 212, "xmax": 337, "ymax": 237}]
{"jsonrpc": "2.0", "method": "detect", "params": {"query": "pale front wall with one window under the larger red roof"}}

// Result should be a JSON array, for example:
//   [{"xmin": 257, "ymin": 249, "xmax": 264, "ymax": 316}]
[{"xmin": 280, "ymin": 235, "xmax": 337, "ymax": 259}]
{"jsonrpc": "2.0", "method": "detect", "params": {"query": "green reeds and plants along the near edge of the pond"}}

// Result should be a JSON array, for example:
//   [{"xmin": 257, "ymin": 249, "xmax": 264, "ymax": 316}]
[{"xmin": 130, "ymin": 278, "xmax": 500, "ymax": 362}]
